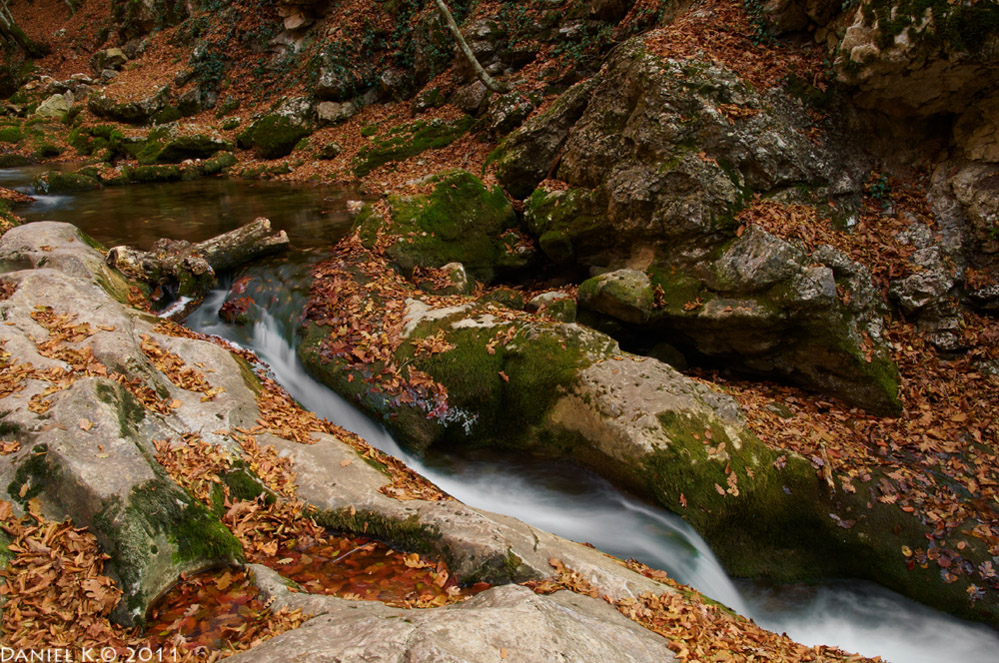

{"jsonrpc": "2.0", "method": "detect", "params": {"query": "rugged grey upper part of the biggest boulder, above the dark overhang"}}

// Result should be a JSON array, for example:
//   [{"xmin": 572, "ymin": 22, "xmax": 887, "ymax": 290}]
[{"xmin": 498, "ymin": 38, "xmax": 864, "ymax": 239}]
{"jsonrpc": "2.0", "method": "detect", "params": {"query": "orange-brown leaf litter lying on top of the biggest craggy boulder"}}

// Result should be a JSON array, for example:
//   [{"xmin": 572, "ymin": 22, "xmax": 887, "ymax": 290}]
[{"xmin": 645, "ymin": 0, "xmax": 826, "ymax": 91}]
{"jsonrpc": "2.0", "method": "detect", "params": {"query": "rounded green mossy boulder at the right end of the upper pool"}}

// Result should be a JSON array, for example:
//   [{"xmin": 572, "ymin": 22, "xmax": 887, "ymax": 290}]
[{"xmin": 374, "ymin": 170, "xmax": 517, "ymax": 283}]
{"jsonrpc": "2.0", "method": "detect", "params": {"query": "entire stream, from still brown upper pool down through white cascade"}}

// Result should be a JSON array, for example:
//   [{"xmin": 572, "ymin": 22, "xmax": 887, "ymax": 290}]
[{"xmin": 9, "ymin": 169, "xmax": 999, "ymax": 663}]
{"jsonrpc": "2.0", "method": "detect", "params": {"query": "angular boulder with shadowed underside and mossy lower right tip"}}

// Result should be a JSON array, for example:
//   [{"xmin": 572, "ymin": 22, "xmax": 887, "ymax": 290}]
[{"xmin": 636, "ymin": 228, "xmax": 901, "ymax": 415}]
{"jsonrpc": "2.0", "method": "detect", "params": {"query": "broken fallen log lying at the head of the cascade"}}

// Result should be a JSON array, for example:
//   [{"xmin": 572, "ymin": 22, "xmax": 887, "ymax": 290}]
[{"xmin": 105, "ymin": 217, "xmax": 289, "ymax": 304}]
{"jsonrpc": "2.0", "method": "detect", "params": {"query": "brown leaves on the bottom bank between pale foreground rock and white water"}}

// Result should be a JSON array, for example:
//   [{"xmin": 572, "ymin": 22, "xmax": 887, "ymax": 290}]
[{"xmin": 524, "ymin": 558, "xmax": 880, "ymax": 663}]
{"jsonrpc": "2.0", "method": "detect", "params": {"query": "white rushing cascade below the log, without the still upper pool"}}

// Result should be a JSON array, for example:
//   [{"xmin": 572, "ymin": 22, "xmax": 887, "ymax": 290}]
[{"xmin": 185, "ymin": 267, "xmax": 999, "ymax": 663}]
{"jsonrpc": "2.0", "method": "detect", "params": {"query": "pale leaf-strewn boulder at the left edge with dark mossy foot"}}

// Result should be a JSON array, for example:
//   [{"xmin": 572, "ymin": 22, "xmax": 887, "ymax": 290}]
[{"xmin": 0, "ymin": 222, "xmax": 246, "ymax": 623}]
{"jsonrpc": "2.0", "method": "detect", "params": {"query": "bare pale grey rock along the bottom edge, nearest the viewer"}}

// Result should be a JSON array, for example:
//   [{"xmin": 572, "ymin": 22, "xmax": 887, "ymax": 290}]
[{"xmin": 233, "ymin": 585, "xmax": 676, "ymax": 663}]
